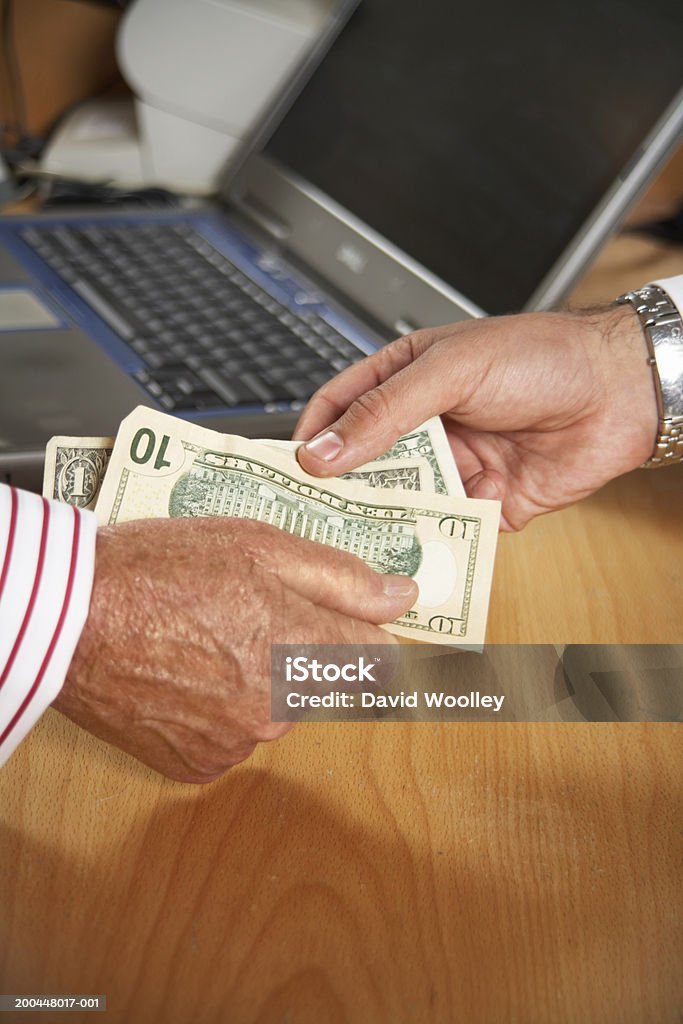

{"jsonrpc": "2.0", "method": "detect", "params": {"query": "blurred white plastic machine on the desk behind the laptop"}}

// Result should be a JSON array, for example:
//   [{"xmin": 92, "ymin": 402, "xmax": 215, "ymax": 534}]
[{"xmin": 41, "ymin": 0, "xmax": 357, "ymax": 196}]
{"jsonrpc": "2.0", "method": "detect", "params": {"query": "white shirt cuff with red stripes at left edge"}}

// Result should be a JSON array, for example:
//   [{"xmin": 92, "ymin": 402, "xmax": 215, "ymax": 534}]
[{"xmin": 0, "ymin": 484, "xmax": 96, "ymax": 765}]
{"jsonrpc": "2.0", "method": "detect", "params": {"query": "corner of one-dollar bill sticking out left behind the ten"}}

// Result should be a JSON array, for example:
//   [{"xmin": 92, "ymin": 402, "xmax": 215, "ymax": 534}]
[{"xmin": 43, "ymin": 436, "xmax": 114, "ymax": 509}]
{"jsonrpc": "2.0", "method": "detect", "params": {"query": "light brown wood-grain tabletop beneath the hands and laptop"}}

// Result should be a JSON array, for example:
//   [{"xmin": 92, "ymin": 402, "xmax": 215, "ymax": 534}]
[{"xmin": 0, "ymin": 9, "xmax": 683, "ymax": 1024}]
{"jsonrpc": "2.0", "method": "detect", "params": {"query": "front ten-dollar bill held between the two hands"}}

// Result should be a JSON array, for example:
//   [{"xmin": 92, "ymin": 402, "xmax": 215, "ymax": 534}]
[{"xmin": 96, "ymin": 407, "xmax": 500, "ymax": 645}]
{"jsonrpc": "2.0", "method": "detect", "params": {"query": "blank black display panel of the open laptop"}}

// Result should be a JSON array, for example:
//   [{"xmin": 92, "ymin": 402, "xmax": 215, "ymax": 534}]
[{"xmin": 266, "ymin": 0, "xmax": 683, "ymax": 313}]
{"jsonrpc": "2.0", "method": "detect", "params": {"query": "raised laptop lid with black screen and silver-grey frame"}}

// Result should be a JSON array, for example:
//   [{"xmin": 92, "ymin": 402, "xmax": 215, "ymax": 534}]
[{"xmin": 230, "ymin": 0, "xmax": 683, "ymax": 321}]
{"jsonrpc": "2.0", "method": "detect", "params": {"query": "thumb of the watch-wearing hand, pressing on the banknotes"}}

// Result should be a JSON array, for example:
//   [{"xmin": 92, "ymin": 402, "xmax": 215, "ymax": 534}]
[{"xmin": 297, "ymin": 344, "xmax": 471, "ymax": 476}]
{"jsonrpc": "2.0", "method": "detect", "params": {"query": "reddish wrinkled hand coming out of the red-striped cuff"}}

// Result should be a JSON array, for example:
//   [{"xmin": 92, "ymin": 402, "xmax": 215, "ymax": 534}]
[{"xmin": 54, "ymin": 519, "xmax": 417, "ymax": 782}]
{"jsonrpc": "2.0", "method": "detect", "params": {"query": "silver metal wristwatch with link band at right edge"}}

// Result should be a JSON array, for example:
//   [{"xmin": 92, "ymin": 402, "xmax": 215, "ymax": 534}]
[{"xmin": 616, "ymin": 285, "xmax": 683, "ymax": 469}]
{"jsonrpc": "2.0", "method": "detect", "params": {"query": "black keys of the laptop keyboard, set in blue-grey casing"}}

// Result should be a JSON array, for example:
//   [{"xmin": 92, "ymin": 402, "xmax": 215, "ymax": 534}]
[{"xmin": 22, "ymin": 223, "xmax": 365, "ymax": 412}]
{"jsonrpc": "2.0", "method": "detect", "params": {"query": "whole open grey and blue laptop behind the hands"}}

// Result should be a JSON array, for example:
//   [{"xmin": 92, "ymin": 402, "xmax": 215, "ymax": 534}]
[{"xmin": 0, "ymin": 0, "xmax": 683, "ymax": 487}]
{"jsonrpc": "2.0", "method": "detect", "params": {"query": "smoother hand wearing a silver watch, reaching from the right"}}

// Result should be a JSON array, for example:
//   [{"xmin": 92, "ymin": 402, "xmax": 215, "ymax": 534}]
[{"xmin": 294, "ymin": 306, "xmax": 657, "ymax": 529}]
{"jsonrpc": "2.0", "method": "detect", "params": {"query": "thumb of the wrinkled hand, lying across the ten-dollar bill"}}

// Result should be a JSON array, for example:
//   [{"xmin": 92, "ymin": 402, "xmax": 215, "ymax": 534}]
[{"xmin": 256, "ymin": 527, "xmax": 419, "ymax": 624}]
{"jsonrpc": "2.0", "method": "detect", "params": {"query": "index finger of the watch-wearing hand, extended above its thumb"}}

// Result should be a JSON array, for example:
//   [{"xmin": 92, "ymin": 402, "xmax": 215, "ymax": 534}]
[{"xmin": 292, "ymin": 329, "xmax": 436, "ymax": 440}]
